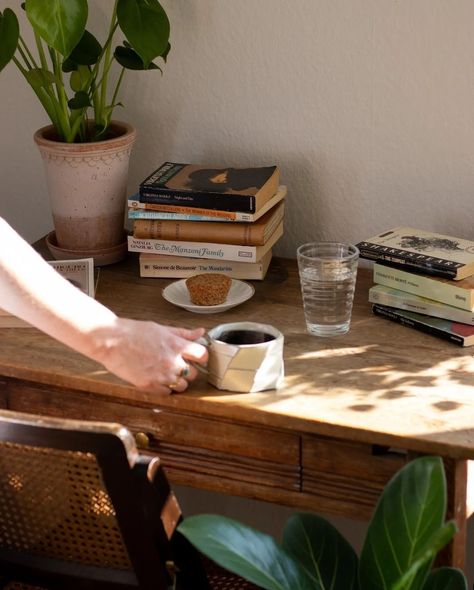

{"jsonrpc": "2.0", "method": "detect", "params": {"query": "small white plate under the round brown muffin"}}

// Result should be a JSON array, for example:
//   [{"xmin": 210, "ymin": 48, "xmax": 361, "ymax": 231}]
[{"xmin": 161, "ymin": 279, "xmax": 255, "ymax": 313}]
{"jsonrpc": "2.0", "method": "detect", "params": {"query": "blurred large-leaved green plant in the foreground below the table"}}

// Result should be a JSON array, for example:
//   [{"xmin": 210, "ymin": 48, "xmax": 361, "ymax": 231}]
[{"xmin": 179, "ymin": 457, "xmax": 467, "ymax": 590}]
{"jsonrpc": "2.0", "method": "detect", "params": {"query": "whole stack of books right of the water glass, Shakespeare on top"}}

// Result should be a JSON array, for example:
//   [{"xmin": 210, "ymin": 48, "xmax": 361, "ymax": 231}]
[{"xmin": 357, "ymin": 227, "xmax": 474, "ymax": 346}]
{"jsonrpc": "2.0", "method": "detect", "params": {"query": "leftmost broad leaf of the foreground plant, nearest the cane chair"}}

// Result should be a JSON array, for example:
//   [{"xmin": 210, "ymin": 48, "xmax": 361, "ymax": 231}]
[{"xmin": 178, "ymin": 514, "xmax": 314, "ymax": 590}]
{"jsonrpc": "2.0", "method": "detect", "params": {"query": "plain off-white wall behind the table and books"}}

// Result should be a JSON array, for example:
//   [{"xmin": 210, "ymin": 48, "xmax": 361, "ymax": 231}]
[{"xmin": 0, "ymin": 0, "xmax": 474, "ymax": 584}]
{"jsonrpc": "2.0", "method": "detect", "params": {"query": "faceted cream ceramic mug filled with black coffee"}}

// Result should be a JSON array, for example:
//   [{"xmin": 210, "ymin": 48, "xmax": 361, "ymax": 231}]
[{"xmin": 196, "ymin": 322, "xmax": 284, "ymax": 393}]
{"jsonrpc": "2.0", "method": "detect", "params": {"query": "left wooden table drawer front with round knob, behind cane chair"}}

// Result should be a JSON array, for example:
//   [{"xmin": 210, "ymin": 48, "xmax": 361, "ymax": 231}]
[{"xmin": 7, "ymin": 381, "xmax": 300, "ymax": 497}]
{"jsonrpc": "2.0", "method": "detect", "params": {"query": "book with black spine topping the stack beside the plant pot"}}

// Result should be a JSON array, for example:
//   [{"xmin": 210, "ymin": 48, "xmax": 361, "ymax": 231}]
[{"xmin": 139, "ymin": 162, "xmax": 280, "ymax": 213}]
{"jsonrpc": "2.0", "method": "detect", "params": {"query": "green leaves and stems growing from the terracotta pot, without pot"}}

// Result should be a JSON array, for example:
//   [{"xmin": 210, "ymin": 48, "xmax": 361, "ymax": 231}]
[{"xmin": 0, "ymin": 0, "xmax": 170, "ymax": 143}]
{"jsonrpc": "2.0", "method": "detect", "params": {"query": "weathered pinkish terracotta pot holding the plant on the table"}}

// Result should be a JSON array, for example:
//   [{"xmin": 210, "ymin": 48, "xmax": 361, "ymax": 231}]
[{"xmin": 34, "ymin": 121, "xmax": 136, "ymax": 264}]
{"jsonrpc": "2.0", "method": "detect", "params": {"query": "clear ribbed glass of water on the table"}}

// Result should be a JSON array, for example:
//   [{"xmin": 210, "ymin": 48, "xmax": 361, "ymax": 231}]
[{"xmin": 296, "ymin": 242, "xmax": 359, "ymax": 336}]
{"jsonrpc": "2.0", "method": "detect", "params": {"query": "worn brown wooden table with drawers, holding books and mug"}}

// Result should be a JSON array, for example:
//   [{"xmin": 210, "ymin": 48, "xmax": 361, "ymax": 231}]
[{"xmin": 0, "ymin": 255, "xmax": 474, "ymax": 567}]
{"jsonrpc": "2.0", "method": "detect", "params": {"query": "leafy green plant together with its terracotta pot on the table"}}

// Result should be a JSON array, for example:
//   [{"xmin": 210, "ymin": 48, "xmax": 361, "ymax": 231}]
[{"xmin": 0, "ymin": 0, "xmax": 170, "ymax": 262}]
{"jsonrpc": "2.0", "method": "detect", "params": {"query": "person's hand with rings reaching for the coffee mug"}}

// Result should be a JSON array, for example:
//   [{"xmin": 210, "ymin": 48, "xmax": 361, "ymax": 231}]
[{"xmin": 95, "ymin": 318, "xmax": 208, "ymax": 394}]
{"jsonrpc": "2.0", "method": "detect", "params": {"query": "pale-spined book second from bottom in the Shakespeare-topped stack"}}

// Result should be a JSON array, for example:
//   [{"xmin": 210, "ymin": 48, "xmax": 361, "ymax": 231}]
[{"xmin": 369, "ymin": 285, "xmax": 474, "ymax": 326}]
